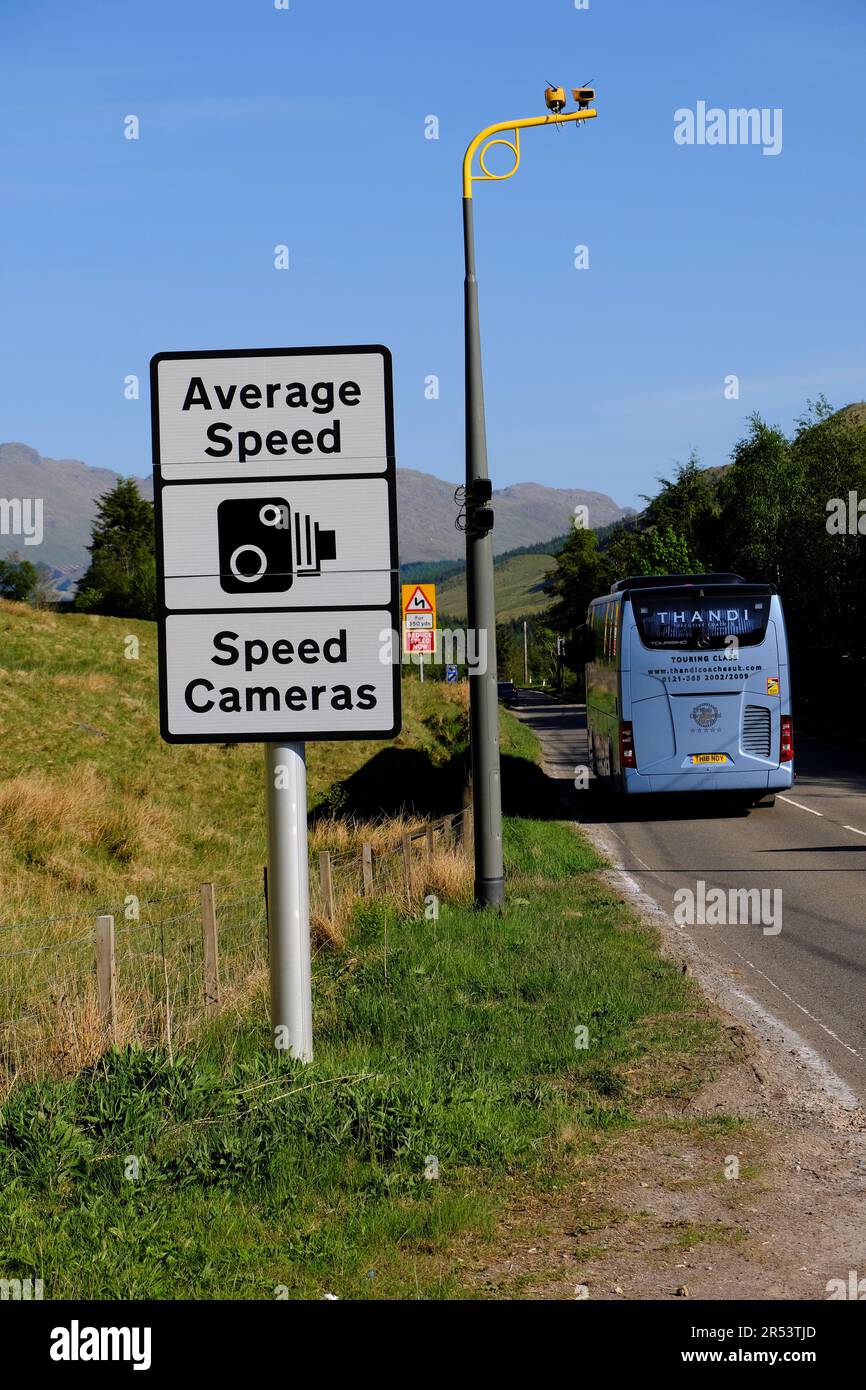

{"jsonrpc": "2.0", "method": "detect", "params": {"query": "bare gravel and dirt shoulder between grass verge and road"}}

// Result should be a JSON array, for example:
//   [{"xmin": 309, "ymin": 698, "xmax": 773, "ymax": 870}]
[{"xmin": 475, "ymin": 695, "xmax": 866, "ymax": 1301}]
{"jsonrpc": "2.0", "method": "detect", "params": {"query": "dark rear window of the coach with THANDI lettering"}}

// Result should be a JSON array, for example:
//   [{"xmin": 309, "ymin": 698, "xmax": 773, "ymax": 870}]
[{"xmin": 631, "ymin": 592, "xmax": 770, "ymax": 651}]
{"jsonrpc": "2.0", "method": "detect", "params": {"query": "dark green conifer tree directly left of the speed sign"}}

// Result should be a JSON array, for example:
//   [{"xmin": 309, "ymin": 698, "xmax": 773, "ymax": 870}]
[{"xmin": 75, "ymin": 478, "xmax": 156, "ymax": 619}]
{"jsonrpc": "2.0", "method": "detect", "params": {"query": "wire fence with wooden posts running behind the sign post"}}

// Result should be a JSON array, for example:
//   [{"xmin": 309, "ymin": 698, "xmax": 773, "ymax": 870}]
[{"xmin": 0, "ymin": 812, "xmax": 467, "ymax": 1091}]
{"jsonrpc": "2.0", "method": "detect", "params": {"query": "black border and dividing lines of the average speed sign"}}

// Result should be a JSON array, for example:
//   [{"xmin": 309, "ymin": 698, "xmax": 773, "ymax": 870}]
[{"xmin": 150, "ymin": 343, "xmax": 402, "ymax": 744}]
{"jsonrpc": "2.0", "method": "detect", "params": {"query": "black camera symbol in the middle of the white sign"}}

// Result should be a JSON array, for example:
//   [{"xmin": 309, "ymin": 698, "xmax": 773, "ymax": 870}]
[{"xmin": 217, "ymin": 498, "xmax": 336, "ymax": 594}]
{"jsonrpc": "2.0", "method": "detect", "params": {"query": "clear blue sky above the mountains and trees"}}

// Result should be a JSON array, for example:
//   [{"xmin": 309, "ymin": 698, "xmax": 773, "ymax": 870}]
[{"xmin": 0, "ymin": 0, "xmax": 866, "ymax": 505}]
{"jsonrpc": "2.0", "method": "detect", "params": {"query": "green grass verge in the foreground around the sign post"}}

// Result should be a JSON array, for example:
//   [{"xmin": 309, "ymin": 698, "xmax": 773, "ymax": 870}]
[{"xmin": 0, "ymin": 820, "xmax": 714, "ymax": 1298}]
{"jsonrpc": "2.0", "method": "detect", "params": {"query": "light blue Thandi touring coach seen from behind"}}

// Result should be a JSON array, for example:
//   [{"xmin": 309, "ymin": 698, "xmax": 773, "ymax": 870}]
[{"xmin": 578, "ymin": 574, "xmax": 794, "ymax": 806}]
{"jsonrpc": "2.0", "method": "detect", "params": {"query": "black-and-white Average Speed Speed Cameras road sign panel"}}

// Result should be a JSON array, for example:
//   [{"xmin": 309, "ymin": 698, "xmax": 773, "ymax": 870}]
[{"xmin": 150, "ymin": 346, "xmax": 400, "ymax": 744}]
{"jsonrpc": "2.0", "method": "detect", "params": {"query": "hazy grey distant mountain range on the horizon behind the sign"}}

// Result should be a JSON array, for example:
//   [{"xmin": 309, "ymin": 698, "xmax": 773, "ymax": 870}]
[{"xmin": 0, "ymin": 443, "xmax": 631, "ymax": 591}]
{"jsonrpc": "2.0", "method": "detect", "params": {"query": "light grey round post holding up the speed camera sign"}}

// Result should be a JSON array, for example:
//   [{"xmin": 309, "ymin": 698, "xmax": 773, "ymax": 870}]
[{"xmin": 264, "ymin": 744, "xmax": 313, "ymax": 1062}]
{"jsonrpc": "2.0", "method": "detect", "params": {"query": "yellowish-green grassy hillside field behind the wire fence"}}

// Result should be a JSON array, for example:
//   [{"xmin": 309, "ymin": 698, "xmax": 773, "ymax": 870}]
[{"xmin": 0, "ymin": 600, "xmax": 475, "ymax": 924}]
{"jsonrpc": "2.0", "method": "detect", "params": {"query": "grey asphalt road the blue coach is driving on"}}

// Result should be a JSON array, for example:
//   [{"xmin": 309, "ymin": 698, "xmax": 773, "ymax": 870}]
[{"xmin": 516, "ymin": 692, "xmax": 866, "ymax": 1104}]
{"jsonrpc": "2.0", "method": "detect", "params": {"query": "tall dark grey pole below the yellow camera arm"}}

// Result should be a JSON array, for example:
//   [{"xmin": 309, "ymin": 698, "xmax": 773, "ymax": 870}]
[{"xmin": 463, "ymin": 195, "xmax": 505, "ymax": 908}]
